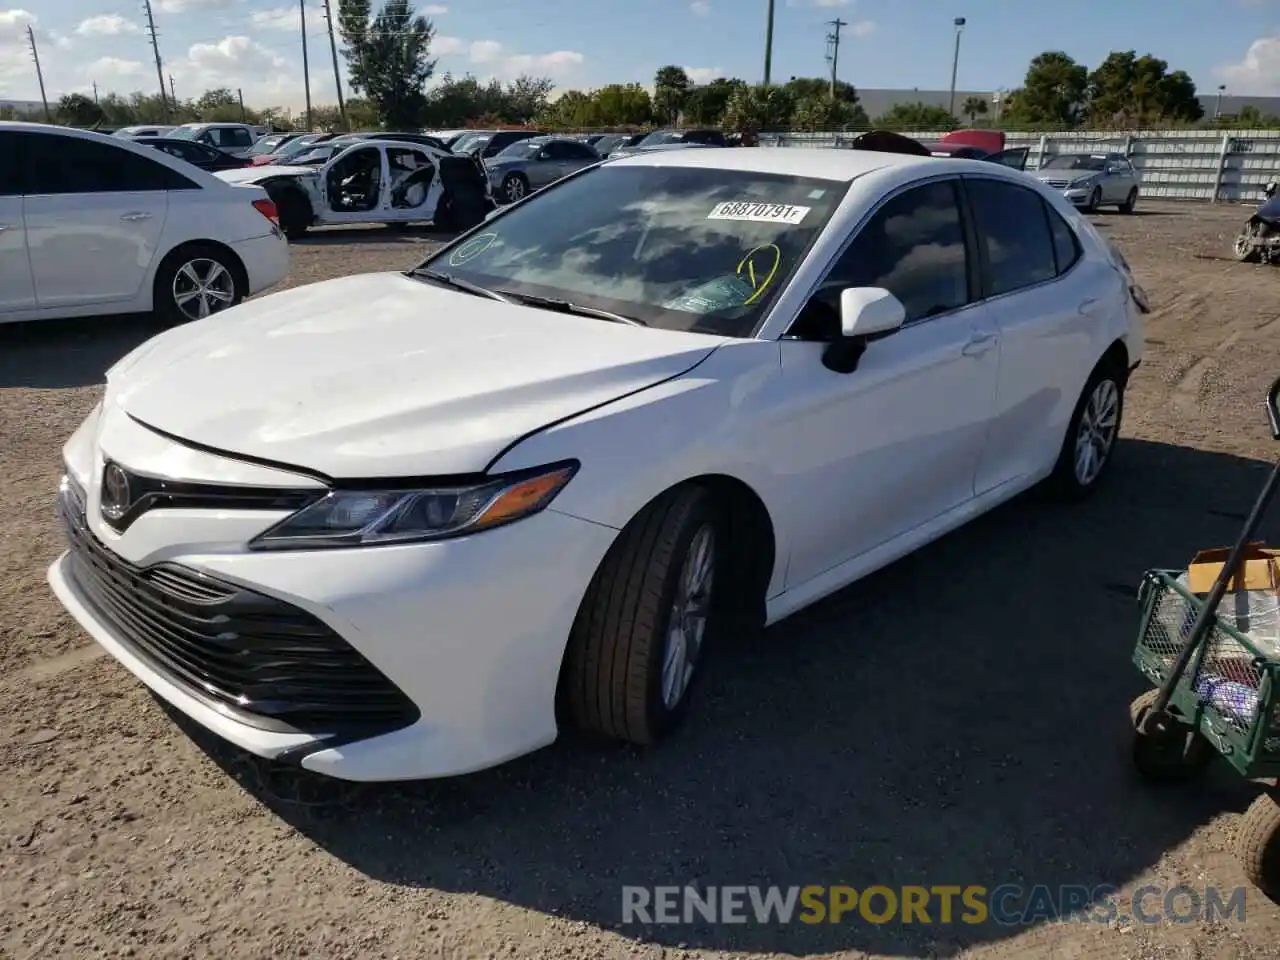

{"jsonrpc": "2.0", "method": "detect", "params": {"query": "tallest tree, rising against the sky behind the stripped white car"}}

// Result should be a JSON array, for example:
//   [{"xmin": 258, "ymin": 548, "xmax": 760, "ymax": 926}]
[{"xmin": 338, "ymin": 0, "xmax": 435, "ymax": 129}]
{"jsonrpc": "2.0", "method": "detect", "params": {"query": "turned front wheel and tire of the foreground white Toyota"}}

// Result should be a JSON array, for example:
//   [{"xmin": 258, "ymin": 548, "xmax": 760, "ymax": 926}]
[{"xmin": 562, "ymin": 486, "xmax": 727, "ymax": 744}]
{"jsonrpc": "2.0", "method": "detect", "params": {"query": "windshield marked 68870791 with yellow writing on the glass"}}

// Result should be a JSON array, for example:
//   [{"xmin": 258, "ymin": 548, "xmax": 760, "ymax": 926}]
[{"xmin": 422, "ymin": 166, "xmax": 847, "ymax": 337}]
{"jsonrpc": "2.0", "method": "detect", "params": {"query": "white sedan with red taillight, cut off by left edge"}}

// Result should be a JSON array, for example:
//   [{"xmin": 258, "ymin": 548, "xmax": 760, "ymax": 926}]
[{"xmin": 0, "ymin": 123, "xmax": 289, "ymax": 323}]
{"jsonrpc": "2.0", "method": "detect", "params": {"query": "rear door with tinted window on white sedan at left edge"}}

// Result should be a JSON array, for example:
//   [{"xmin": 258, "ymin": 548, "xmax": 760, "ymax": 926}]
[{"xmin": 17, "ymin": 132, "xmax": 180, "ymax": 308}]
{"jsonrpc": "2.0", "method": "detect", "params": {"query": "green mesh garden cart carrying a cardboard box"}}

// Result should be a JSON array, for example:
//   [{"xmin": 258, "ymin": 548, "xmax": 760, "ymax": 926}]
[{"xmin": 1129, "ymin": 379, "xmax": 1280, "ymax": 902}]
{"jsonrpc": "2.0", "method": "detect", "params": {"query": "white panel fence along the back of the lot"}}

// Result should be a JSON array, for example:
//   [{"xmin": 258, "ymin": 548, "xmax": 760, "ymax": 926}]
[{"xmin": 760, "ymin": 131, "xmax": 1280, "ymax": 204}]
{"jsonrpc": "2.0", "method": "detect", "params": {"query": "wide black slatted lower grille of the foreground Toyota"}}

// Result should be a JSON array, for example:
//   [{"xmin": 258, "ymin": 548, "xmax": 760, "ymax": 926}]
[{"xmin": 58, "ymin": 484, "xmax": 419, "ymax": 736}]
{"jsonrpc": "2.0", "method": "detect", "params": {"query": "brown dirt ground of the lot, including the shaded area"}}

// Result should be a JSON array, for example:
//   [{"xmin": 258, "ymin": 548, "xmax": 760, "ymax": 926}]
[{"xmin": 0, "ymin": 204, "xmax": 1280, "ymax": 960}]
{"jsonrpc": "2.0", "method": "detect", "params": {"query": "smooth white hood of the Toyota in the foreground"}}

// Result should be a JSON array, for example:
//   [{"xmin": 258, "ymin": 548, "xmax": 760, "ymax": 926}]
[{"xmin": 108, "ymin": 274, "xmax": 723, "ymax": 479}]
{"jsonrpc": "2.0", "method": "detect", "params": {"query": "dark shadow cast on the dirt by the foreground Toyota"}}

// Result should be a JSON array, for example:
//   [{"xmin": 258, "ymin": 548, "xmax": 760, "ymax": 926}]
[{"xmin": 162, "ymin": 440, "xmax": 1266, "ymax": 956}]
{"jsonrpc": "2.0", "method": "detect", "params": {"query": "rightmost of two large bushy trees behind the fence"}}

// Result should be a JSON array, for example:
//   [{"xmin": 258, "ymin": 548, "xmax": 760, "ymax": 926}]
[{"xmin": 1089, "ymin": 50, "xmax": 1204, "ymax": 127}]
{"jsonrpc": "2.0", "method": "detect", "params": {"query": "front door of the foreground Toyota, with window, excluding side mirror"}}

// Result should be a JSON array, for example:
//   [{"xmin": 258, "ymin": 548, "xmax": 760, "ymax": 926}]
[{"xmin": 763, "ymin": 179, "xmax": 1000, "ymax": 589}]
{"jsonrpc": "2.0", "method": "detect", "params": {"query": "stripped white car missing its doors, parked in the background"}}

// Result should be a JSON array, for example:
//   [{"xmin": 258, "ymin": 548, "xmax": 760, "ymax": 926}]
[{"xmin": 215, "ymin": 140, "xmax": 494, "ymax": 239}]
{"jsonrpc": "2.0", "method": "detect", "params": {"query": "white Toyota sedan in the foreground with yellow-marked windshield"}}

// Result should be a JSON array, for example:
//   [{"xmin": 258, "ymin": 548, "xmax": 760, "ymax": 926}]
[{"xmin": 49, "ymin": 148, "xmax": 1143, "ymax": 781}]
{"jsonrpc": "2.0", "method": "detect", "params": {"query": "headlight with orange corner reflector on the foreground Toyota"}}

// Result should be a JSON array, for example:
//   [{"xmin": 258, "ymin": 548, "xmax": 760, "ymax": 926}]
[{"xmin": 250, "ymin": 461, "xmax": 579, "ymax": 550}]
